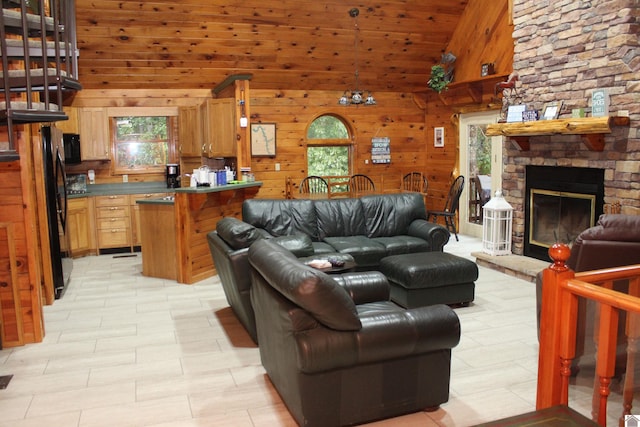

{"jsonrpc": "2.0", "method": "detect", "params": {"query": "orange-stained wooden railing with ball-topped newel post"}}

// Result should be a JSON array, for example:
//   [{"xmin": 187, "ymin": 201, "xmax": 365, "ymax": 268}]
[{"xmin": 536, "ymin": 244, "xmax": 640, "ymax": 426}]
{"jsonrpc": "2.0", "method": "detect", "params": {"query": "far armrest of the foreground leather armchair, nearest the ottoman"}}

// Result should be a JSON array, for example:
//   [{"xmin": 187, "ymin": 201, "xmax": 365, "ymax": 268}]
[{"xmin": 333, "ymin": 271, "xmax": 390, "ymax": 305}]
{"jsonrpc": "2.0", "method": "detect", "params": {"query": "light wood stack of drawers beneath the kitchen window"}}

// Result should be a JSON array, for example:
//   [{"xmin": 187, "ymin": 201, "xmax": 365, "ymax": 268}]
[{"xmin": 95, "ymin": 195, "xmax": 131, "ymax": 252}]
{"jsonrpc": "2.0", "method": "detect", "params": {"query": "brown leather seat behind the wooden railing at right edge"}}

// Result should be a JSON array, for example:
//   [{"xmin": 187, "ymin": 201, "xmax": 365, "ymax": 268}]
[{"xmin": 536, "ymin": 214, "xmax": 640, "ymax": 366}]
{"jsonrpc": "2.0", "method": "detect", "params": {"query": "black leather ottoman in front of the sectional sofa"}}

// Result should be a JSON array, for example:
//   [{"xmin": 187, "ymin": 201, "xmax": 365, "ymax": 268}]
[{"xmin": 380, "ymin": 252, "xmax": 478, "ymax": 308}]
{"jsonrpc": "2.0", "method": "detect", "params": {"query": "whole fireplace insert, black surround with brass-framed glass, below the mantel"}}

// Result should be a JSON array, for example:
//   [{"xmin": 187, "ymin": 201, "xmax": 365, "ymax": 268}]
[{"xmin": 524, "ymin": 166, "xmax": 604, "ymax": 261}]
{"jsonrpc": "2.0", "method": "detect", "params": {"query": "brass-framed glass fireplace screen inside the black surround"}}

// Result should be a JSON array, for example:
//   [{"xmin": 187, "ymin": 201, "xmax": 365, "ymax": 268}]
[{"xmin": 529, "ymin": 189, "xmax": 596, "ymax": 248}]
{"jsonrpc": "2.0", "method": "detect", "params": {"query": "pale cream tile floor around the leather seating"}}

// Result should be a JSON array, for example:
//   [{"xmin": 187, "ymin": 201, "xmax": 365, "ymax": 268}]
[{"xmin": 0, "ymin": 236, "xmax": 604, "ymax": 427}]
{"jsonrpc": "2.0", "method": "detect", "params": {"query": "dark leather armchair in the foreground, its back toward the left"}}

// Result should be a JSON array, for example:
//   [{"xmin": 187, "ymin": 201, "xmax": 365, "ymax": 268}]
[{"xmin": 248, "ymin": 239, "xmax": 460, "ymax": 427}]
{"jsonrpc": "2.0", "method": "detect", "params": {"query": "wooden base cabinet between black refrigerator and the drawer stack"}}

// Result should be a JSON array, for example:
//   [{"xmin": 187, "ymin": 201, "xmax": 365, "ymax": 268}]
[{"xmin": 67, "ymin": 197, "xmax": 95, "ymax": 258}]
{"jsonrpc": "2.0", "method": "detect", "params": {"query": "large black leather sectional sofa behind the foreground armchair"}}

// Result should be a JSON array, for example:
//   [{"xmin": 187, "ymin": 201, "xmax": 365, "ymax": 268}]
[{"xmin": 207, "ymin": 193, "xmax": 449, "ymax": 342}]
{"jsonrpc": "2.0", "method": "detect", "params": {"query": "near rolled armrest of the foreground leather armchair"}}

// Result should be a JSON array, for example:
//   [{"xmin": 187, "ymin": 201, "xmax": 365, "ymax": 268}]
[{"xmin": 296, "ymin": 305, "xmax": 460, "ymax": 374}]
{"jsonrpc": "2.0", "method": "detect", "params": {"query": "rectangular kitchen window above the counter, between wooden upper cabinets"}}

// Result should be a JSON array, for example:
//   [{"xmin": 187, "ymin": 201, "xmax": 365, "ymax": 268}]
[{"xmin": 111, "ymin": 116, "xmax": 175, "ymax": 174}]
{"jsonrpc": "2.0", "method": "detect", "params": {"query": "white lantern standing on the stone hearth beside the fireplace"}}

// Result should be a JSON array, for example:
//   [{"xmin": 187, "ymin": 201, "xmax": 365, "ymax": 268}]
[{"xmin": 482, "ymin": 190, "xmax": 513, "ymax": 255}]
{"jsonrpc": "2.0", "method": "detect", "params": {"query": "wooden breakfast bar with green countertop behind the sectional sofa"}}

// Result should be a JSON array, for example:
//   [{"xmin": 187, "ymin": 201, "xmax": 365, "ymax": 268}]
[{"xmin": 138, "ymin": 181, "xmax": 262, "ymax": 284}]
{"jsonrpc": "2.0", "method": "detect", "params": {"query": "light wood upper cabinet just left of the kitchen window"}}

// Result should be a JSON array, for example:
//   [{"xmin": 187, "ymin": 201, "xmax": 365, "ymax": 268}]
[{"xmin": 78, "ymin": 107, "xmax": 111, "ymax": 160}]
